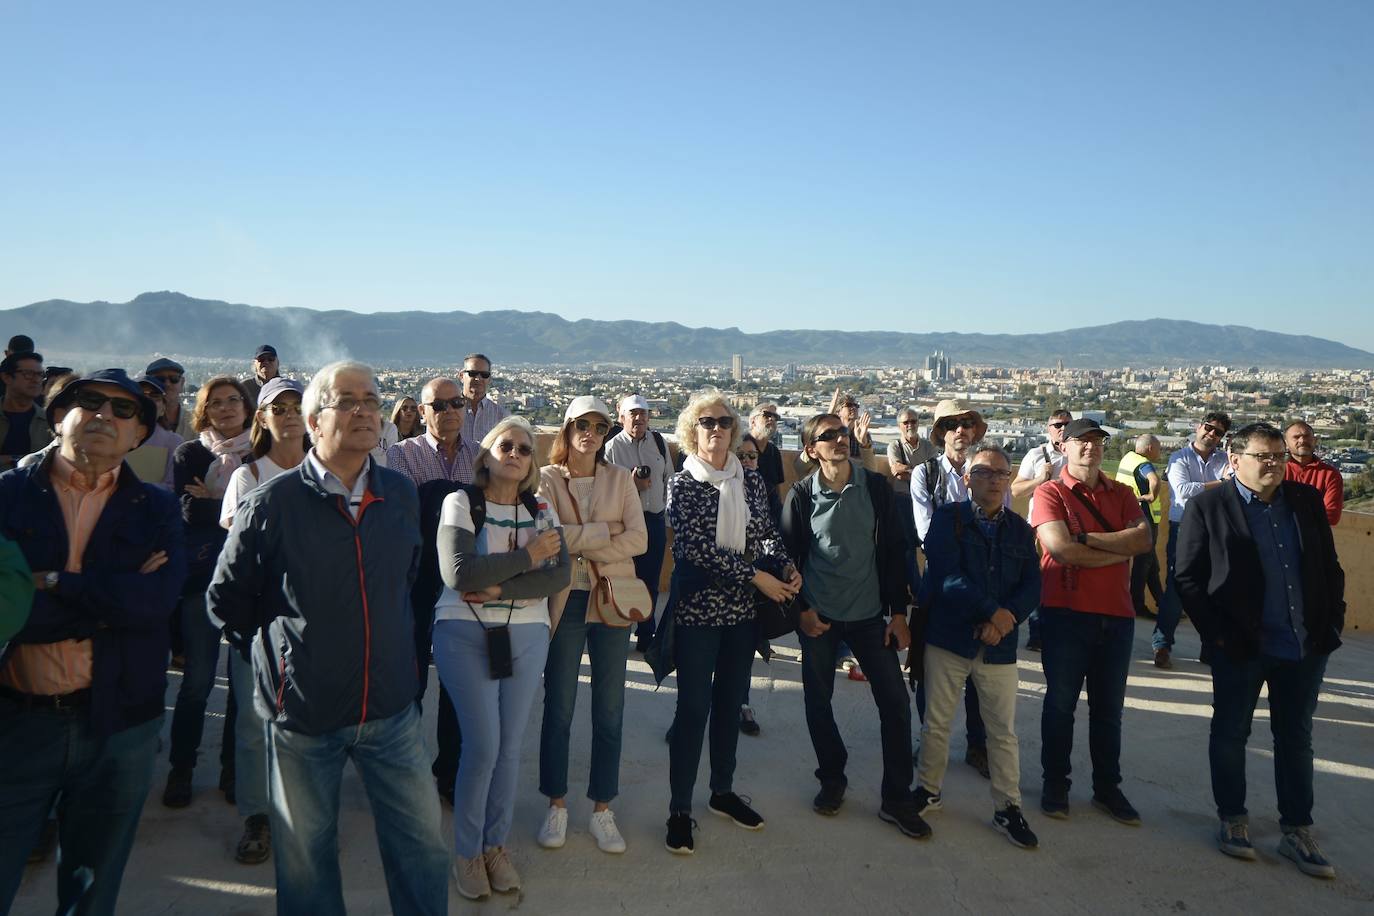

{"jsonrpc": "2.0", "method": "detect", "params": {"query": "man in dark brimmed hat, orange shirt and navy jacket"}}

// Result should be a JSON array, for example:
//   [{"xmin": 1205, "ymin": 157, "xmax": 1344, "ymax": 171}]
[{"xmin": 0, "ymin": 369, "xmax": 185, "ymax": 913}]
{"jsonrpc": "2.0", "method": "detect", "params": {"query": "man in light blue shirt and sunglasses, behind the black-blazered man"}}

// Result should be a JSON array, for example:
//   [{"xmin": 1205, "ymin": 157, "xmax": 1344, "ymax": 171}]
[{"xmin": 1150, "ymin": 411, "xmax": 1232, "ymax": 667}]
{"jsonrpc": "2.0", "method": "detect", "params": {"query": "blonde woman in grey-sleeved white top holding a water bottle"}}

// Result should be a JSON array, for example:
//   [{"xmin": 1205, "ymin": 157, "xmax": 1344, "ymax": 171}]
[{"xmin": 434, "ymin": 417, "xmax": 570, "ymax": 900}]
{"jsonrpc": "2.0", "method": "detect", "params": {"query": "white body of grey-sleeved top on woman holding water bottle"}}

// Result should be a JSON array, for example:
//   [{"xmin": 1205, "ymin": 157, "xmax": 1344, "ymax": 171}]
[{"xmin": 434, "ymin": 490, "xmax": 558, "ymax": 626}]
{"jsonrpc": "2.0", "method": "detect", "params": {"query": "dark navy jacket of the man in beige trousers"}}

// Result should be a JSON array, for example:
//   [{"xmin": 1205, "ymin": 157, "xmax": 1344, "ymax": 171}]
[{"xmin": 921, "ymin": 501, "xmax": 1040, "ymax": 665}]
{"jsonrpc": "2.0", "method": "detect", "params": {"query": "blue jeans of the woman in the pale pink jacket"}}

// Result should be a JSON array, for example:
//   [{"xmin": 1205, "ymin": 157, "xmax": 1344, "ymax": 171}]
[{"xmin": 539, "ymin": 591, "xmax": 629, "ymax": 803}]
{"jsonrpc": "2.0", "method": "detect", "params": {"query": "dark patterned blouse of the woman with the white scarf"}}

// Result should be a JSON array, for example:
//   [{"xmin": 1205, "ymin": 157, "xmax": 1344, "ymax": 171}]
[{"xmin": 668, "ymin": 470, "xmax": 789, "ymax": 626}]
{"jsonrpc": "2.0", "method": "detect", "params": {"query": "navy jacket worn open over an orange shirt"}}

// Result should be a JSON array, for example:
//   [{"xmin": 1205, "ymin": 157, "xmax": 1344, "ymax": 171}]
[{"xmin": 0, "ymin": 453, "xmax": 185, "ymax": 736}]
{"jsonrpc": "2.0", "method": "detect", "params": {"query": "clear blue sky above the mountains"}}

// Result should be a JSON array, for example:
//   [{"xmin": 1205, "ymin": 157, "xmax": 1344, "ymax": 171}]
[{"xmin": 0, "ymin": 0, "xmax": 1374, "ymax": 350}]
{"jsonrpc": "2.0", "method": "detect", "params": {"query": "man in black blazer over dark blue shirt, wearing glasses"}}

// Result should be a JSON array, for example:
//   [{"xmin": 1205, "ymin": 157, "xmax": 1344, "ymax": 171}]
[{"xmin": 1176, "ymin": 423, "xmax": 1345, "ymax": 878}]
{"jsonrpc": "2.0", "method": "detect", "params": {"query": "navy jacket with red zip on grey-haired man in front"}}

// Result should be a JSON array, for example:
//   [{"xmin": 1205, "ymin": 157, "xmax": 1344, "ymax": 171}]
[{"xmin": 206, "ymin": 459, "xmax": 420, "ymax": 735}]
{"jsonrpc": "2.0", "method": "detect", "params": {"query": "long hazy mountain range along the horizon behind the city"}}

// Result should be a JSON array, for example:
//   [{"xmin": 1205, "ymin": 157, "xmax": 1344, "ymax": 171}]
[{"xmin": 0, "ymin": 291, "xmax": 1374, "ymax": 368}]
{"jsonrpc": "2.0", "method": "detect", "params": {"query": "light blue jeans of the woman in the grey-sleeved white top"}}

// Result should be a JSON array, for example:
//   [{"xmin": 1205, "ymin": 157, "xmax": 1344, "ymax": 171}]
[{"xmin": 434, "ymin": 621, "xmax": 548, "ymax": 858}]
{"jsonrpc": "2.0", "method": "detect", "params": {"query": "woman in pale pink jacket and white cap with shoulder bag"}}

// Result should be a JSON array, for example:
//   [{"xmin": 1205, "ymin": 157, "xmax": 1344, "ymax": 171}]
[{"xmin": 539, "ymin": 396, "xmax": 649, "ymax": 853}]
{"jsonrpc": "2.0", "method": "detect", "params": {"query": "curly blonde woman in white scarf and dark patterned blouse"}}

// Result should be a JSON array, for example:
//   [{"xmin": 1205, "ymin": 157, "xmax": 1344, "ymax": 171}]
[{"xmin": 666, "ymin": 389, "xmax": 801, "ymax": 856}]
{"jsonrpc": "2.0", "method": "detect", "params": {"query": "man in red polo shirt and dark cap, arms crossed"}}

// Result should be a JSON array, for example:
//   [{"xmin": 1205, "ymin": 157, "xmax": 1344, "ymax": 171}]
[{"xmin": 1031, "ymin": 419, "xmax": 1150, "ymax": 825}]
